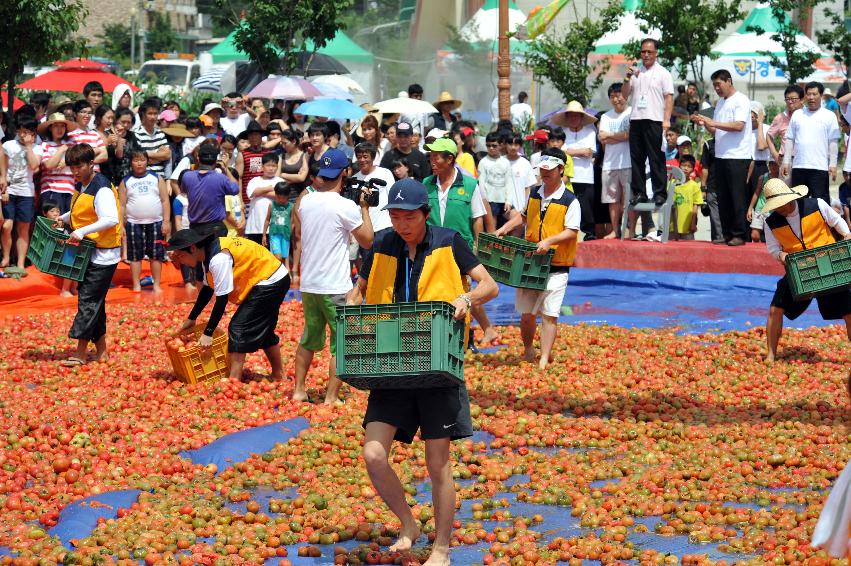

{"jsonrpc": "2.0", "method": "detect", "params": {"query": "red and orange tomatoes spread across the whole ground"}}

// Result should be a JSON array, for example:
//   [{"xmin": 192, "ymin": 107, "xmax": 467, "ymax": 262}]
[{"xmin": 0, "ymin": 302, "xmax": 851, "ymax": 564}]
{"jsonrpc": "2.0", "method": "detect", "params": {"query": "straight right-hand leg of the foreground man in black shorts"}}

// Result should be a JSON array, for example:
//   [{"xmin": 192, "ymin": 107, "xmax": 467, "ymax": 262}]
[{"xmin": 424, "ymin": 438, "xmax": 455, "ymax": 566}]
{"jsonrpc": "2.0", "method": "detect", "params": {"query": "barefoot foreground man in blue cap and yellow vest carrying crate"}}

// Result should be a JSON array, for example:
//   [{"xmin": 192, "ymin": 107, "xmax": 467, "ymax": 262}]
[{"xmin": 346, "ymin": 179, "xmax": 499, "ymax": 565}]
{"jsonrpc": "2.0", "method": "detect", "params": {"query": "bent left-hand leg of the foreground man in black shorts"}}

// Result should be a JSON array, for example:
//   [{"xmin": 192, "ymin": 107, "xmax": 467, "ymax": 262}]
[{"xmin": 363, "ymin": 421, "xmax": 422, "ymax": 551}]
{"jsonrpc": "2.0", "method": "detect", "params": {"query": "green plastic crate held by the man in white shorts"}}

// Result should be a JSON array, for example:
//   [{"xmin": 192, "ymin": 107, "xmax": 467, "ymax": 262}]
[{"xmin": 476, "ymin": 234, "xmax": 555, "ymax": 290}]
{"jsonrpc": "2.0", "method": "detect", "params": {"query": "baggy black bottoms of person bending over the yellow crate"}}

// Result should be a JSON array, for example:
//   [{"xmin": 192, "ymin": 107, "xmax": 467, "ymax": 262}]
[{"xmin": 228, "ymin": 275, "xmax": 290, "ymax": 354}]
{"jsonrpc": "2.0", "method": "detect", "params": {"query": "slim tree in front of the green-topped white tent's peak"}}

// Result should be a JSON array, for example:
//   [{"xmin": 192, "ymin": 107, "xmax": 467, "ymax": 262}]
[{"xmin": 748, "ymin": 0, "xmax": 821, "ymax": 84}]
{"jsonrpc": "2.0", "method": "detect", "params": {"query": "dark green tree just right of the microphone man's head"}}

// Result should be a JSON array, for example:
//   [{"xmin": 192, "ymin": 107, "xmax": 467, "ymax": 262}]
[{"xmin": 624, "ymin": 0, "xmax": 745, "ymax": 93}]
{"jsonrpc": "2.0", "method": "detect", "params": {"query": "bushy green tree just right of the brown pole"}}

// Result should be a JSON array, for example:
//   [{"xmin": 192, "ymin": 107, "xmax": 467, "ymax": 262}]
[{"xmin": 524, "ymin": 0, "xmax": 623, "ymax": 104}]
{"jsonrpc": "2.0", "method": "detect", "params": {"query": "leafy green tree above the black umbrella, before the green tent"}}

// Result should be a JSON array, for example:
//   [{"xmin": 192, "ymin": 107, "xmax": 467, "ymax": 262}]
[{"xmin": 218, "ymin": 0, "xmax": 354, "ymax": 74}]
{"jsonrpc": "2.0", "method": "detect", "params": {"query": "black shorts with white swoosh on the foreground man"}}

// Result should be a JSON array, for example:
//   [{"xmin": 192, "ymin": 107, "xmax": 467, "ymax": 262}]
[{"xmin": 363, "ymin": 386, "xmax": 473, "ymax": 444}]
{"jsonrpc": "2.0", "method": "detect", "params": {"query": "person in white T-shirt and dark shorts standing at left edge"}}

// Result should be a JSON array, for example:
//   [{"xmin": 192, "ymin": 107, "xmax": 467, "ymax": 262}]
[{"xmin": 0, "ymin": 116, "xmax": 41, "ymax": 273}]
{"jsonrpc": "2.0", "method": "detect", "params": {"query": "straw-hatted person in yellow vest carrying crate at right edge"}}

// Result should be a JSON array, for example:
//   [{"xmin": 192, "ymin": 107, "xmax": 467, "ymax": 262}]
[{"xmin": 762, "ymin": 179, "xmax": 851, "ymax": 362}]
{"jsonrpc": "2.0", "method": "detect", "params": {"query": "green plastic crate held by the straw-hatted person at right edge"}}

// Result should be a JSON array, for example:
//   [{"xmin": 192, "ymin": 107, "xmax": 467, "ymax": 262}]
[{"xmin": 786, "ymin": 241, "xmax": 851, "ymax": 300}]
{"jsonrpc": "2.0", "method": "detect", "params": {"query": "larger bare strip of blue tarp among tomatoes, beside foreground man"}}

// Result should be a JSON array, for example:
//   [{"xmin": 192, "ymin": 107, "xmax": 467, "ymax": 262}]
[{"xmin": 180, "ymin": 417, "xmax": 310, "ymax": 473}]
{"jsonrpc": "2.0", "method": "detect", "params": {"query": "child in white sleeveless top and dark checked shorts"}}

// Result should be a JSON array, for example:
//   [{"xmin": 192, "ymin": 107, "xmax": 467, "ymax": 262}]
[{"xmin": 118, "ymin": 149, "xmax": 171, "ymax": 293}]
